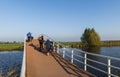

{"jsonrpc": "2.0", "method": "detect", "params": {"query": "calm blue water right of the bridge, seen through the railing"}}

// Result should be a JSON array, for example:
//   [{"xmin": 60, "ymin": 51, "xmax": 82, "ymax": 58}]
[{"xmin": 60, "ymin": 47, "xmax": 120, "ymax": 77}]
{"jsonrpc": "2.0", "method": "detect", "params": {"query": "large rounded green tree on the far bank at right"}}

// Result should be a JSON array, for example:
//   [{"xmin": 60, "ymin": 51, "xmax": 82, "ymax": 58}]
[{"xmin": 81, "ymin": 28, "xmax": 101, "ymax": 48}]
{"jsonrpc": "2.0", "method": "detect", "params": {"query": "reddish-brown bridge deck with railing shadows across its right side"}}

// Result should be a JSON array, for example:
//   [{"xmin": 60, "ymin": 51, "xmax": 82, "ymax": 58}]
[{"xmin": 26, "ymin": 40, "xmax": 93, "ymax": 77}]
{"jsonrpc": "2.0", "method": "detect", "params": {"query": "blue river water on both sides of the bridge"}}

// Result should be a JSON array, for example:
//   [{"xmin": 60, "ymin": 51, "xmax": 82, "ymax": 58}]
[{"xmin": 0, "ymin": 47, "xmax": 120, "ymax": 77}]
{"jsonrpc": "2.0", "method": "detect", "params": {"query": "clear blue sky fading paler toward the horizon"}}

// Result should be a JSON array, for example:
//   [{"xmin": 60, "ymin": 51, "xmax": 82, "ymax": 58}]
[{"xmin": 0, "ymin": 0, "xmax": 120, "ymax": 41}]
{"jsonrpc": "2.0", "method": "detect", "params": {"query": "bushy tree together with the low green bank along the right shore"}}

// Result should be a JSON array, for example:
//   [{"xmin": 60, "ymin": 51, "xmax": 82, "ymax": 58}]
[{"xmin": 61, "ymin": 28, "xmax": 120, "ymax": 49}]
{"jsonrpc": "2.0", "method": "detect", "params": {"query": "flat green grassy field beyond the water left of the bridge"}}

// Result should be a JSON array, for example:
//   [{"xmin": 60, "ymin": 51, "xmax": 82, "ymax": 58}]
[{"xmin": 0, "ymin": 43, "xmax": 24, "ymax": 51}]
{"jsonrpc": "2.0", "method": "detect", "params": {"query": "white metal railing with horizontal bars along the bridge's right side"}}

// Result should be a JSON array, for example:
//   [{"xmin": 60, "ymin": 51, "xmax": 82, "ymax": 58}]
[{"xmin": 57, "ymin": 48, "xmax": 120, "ymax": 77}]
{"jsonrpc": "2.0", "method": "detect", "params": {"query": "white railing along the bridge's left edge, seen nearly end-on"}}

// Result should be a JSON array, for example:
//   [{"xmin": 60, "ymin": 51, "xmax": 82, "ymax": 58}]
[{"xmin": 20, "ymin": 39, "xmax": 26, "ymax": 77}]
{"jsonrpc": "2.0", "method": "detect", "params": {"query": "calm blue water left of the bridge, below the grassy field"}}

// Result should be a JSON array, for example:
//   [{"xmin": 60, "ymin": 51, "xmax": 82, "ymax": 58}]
[{"xmin": 0, "ymin": 51, "xmax": 23, "ymax": 77}]
